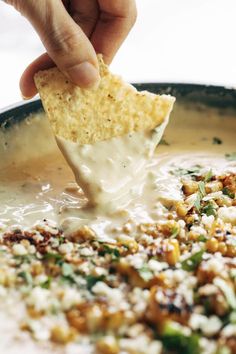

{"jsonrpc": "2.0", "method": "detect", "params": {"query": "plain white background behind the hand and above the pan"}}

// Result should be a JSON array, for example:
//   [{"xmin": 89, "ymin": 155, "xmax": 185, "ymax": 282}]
[{"xmin": 0, "ymin": 0, "xmax": 236, "ymax": 108}]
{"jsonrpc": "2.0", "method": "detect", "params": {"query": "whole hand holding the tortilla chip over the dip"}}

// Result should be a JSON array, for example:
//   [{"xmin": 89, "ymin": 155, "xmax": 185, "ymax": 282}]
[{"xmin": 5, "ymin": 0, "xmax": 136, "ymax": 98}]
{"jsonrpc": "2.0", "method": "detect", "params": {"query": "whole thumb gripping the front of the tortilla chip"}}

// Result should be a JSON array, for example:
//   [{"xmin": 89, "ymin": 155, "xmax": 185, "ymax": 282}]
[{"xmin": 21, "ymin": 0, "xmax": 100, "ymax": 88}]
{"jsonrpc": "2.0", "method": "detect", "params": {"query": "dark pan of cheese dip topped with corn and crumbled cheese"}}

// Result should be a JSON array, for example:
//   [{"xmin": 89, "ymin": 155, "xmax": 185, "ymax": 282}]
[{"xmin": 0, "ymin": 83, "xmax": 236, "ymax": 354}]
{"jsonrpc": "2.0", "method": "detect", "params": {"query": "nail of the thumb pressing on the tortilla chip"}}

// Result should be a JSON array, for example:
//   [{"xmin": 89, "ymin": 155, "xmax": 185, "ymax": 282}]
[{"xmin": 67, "ymin": 61, "xmax": 100, "ymax": 88}]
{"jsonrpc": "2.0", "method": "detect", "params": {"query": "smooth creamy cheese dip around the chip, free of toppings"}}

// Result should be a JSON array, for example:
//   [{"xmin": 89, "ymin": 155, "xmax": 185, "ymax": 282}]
[{"xmin": 0, "ymin": 106, "xmax": 236, "ymax": 241}]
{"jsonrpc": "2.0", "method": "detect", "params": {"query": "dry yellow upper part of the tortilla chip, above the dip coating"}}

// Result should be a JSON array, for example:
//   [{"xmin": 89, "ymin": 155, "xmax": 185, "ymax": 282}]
[{"xmin": 35, "ymin": 55, "xmax": 175, "ymax": 144}]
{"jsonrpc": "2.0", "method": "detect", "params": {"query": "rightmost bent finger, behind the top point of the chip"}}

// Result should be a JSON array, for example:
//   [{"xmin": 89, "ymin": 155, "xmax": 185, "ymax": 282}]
[{"xmin": 91, "ymin": 0, "xmax": 137, "ymax": 64}]
